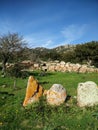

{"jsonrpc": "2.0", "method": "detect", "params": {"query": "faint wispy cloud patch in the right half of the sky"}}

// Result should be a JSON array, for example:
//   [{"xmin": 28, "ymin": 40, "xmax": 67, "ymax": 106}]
[{"xmin": 61, "ymin": 24, "xmax": 87, "ymax": 44}]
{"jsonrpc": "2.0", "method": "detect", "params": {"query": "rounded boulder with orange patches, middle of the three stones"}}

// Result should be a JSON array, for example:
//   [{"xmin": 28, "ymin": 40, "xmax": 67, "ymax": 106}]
[{"xmin": 46, "ymin": 84, "xmax": 67, "ymax": 105}]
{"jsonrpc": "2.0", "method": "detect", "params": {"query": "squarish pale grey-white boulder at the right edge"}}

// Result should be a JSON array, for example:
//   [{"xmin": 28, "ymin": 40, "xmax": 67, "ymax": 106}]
[{"xmin": 77, "ymin": 81, "xmax": 98, "ymax": 107}]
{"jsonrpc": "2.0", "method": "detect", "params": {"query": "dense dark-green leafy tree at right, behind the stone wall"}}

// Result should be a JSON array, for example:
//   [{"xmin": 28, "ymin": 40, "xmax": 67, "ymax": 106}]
[{"xmin": 75, "ymin": 41, "xmax": 98, "ymax": 67}]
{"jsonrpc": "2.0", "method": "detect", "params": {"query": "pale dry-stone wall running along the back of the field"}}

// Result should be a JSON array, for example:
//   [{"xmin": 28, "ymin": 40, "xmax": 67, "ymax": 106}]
[{"xmin": 36, "ymin": 61, "xmax": 98, "ymax": 73}]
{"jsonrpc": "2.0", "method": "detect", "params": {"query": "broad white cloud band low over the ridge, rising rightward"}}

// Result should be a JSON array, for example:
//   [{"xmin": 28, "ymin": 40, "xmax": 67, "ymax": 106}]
[{"xmin": 25, "ymin": 24, "xmax": 88, "ymax": 48}]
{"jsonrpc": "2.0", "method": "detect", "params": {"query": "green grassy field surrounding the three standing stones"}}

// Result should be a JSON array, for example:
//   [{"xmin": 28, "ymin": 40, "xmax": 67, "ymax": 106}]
[{"xmin": 0, "ymin": 72, "xmax": 98, "ymax": 130}]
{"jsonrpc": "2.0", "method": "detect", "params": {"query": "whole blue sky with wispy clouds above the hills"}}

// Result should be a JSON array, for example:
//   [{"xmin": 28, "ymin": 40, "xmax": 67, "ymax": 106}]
[{"xmin": 0, "ymin": 0, "xmax": 98, "ymax": 48}]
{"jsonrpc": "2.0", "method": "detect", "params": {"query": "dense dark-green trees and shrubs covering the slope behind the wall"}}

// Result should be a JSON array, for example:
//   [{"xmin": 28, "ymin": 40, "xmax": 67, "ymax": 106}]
[{"xmin": 29, "ymin": 41, "xmax": 98, "ymax": 67}]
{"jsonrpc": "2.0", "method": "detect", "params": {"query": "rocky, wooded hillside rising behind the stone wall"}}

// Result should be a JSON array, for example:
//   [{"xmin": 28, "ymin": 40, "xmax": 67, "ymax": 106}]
[{"xmin": 0, "ymin": 41, "xmax": 98, "ymax": 68}]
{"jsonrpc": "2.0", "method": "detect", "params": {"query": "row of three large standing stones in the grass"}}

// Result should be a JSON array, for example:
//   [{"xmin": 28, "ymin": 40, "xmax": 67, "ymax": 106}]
[{"xmin": 23, "ymin": 76, "xmax": 98, "ymax": 107}]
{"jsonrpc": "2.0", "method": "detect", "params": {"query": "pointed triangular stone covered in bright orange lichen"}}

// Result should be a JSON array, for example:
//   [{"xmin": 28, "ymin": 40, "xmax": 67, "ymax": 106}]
[{"xmin": 23, "ymin": 76, "xmax": 43, "ymax": 106}]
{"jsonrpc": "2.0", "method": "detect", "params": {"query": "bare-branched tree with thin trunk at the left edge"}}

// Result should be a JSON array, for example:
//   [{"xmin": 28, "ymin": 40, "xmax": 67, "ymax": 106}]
[{"xmin": 0, "ymin": 33, "xmax": 26, "ymax": 74}]
